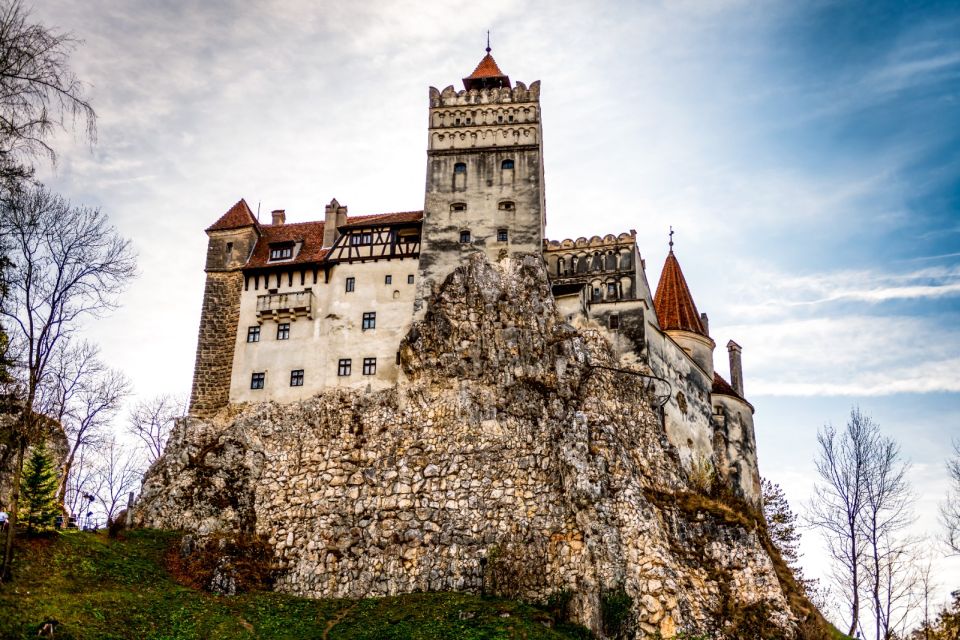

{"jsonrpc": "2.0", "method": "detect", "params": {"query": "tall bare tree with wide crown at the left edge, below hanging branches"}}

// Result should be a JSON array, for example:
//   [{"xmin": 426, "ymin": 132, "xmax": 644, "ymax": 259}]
[{"xmin": 0, "ymin": 186, "xmax": 136, "ymax": 575}]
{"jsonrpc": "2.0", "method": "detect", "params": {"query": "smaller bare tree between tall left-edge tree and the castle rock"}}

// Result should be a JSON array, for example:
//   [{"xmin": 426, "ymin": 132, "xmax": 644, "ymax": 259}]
[{"xmin": 38, "ymin": 340, "xmax": 130, "ymax": 506}]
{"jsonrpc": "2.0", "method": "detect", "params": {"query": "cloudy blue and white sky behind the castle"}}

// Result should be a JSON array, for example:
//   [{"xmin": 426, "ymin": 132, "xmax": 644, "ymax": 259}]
[{"xmin": 34, "ymin": 0, "xmax": 960, "ymax": 624}]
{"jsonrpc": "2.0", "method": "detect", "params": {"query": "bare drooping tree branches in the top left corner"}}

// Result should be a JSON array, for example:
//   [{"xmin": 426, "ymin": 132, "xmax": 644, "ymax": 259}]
[{"xmin": 0, "ymin": 0, "xmax": 96, "ymax": 184}]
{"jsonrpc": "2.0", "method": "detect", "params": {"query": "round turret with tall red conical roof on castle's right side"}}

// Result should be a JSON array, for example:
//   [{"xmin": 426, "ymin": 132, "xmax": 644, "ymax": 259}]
[{"xmin": 653, "ymin": 240, "xmax": 716, "ymax": 380}]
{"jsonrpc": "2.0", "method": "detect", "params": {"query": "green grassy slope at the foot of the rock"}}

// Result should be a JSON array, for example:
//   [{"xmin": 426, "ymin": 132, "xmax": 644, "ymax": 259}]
[{"xmin": 0, "ymin": 530, "xmax": 588, "ymax": 640}]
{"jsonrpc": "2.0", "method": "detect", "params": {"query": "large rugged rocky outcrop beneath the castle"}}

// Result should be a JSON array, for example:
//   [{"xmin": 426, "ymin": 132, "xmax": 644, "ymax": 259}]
[{"xmin": 135, "ymin": 255, "xmax": 795, "ymax": 637}]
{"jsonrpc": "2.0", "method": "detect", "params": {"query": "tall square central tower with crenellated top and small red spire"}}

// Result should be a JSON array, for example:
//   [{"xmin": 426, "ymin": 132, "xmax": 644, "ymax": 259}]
[{"xmin": 414, "ymin": 46, "xmax": 546, "ymax": 319}]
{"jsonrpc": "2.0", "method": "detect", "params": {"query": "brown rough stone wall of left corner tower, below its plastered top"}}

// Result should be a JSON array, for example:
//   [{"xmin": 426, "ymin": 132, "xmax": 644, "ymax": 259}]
[{"xmin": 190, "ymin": 271, "xmax": 243, "ymax": 416}]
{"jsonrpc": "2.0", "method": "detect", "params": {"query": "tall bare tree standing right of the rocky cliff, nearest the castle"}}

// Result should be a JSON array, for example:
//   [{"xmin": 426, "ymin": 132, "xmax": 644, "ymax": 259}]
[{"xmin": 807, "ymin": 407, "xmax": 879, "ymax": 636}]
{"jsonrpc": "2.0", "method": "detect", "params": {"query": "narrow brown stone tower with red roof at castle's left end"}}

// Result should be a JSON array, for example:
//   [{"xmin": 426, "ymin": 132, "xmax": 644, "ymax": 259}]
[{"xmin": 190, "ymin": 200, "xmax": 260, "ymax": 416}]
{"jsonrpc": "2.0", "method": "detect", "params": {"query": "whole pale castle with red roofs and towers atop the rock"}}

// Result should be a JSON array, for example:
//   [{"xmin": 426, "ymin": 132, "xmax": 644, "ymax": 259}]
[{"xmin": 190, "ymin": 47, "xmax": 760, "ymax": 504}]
